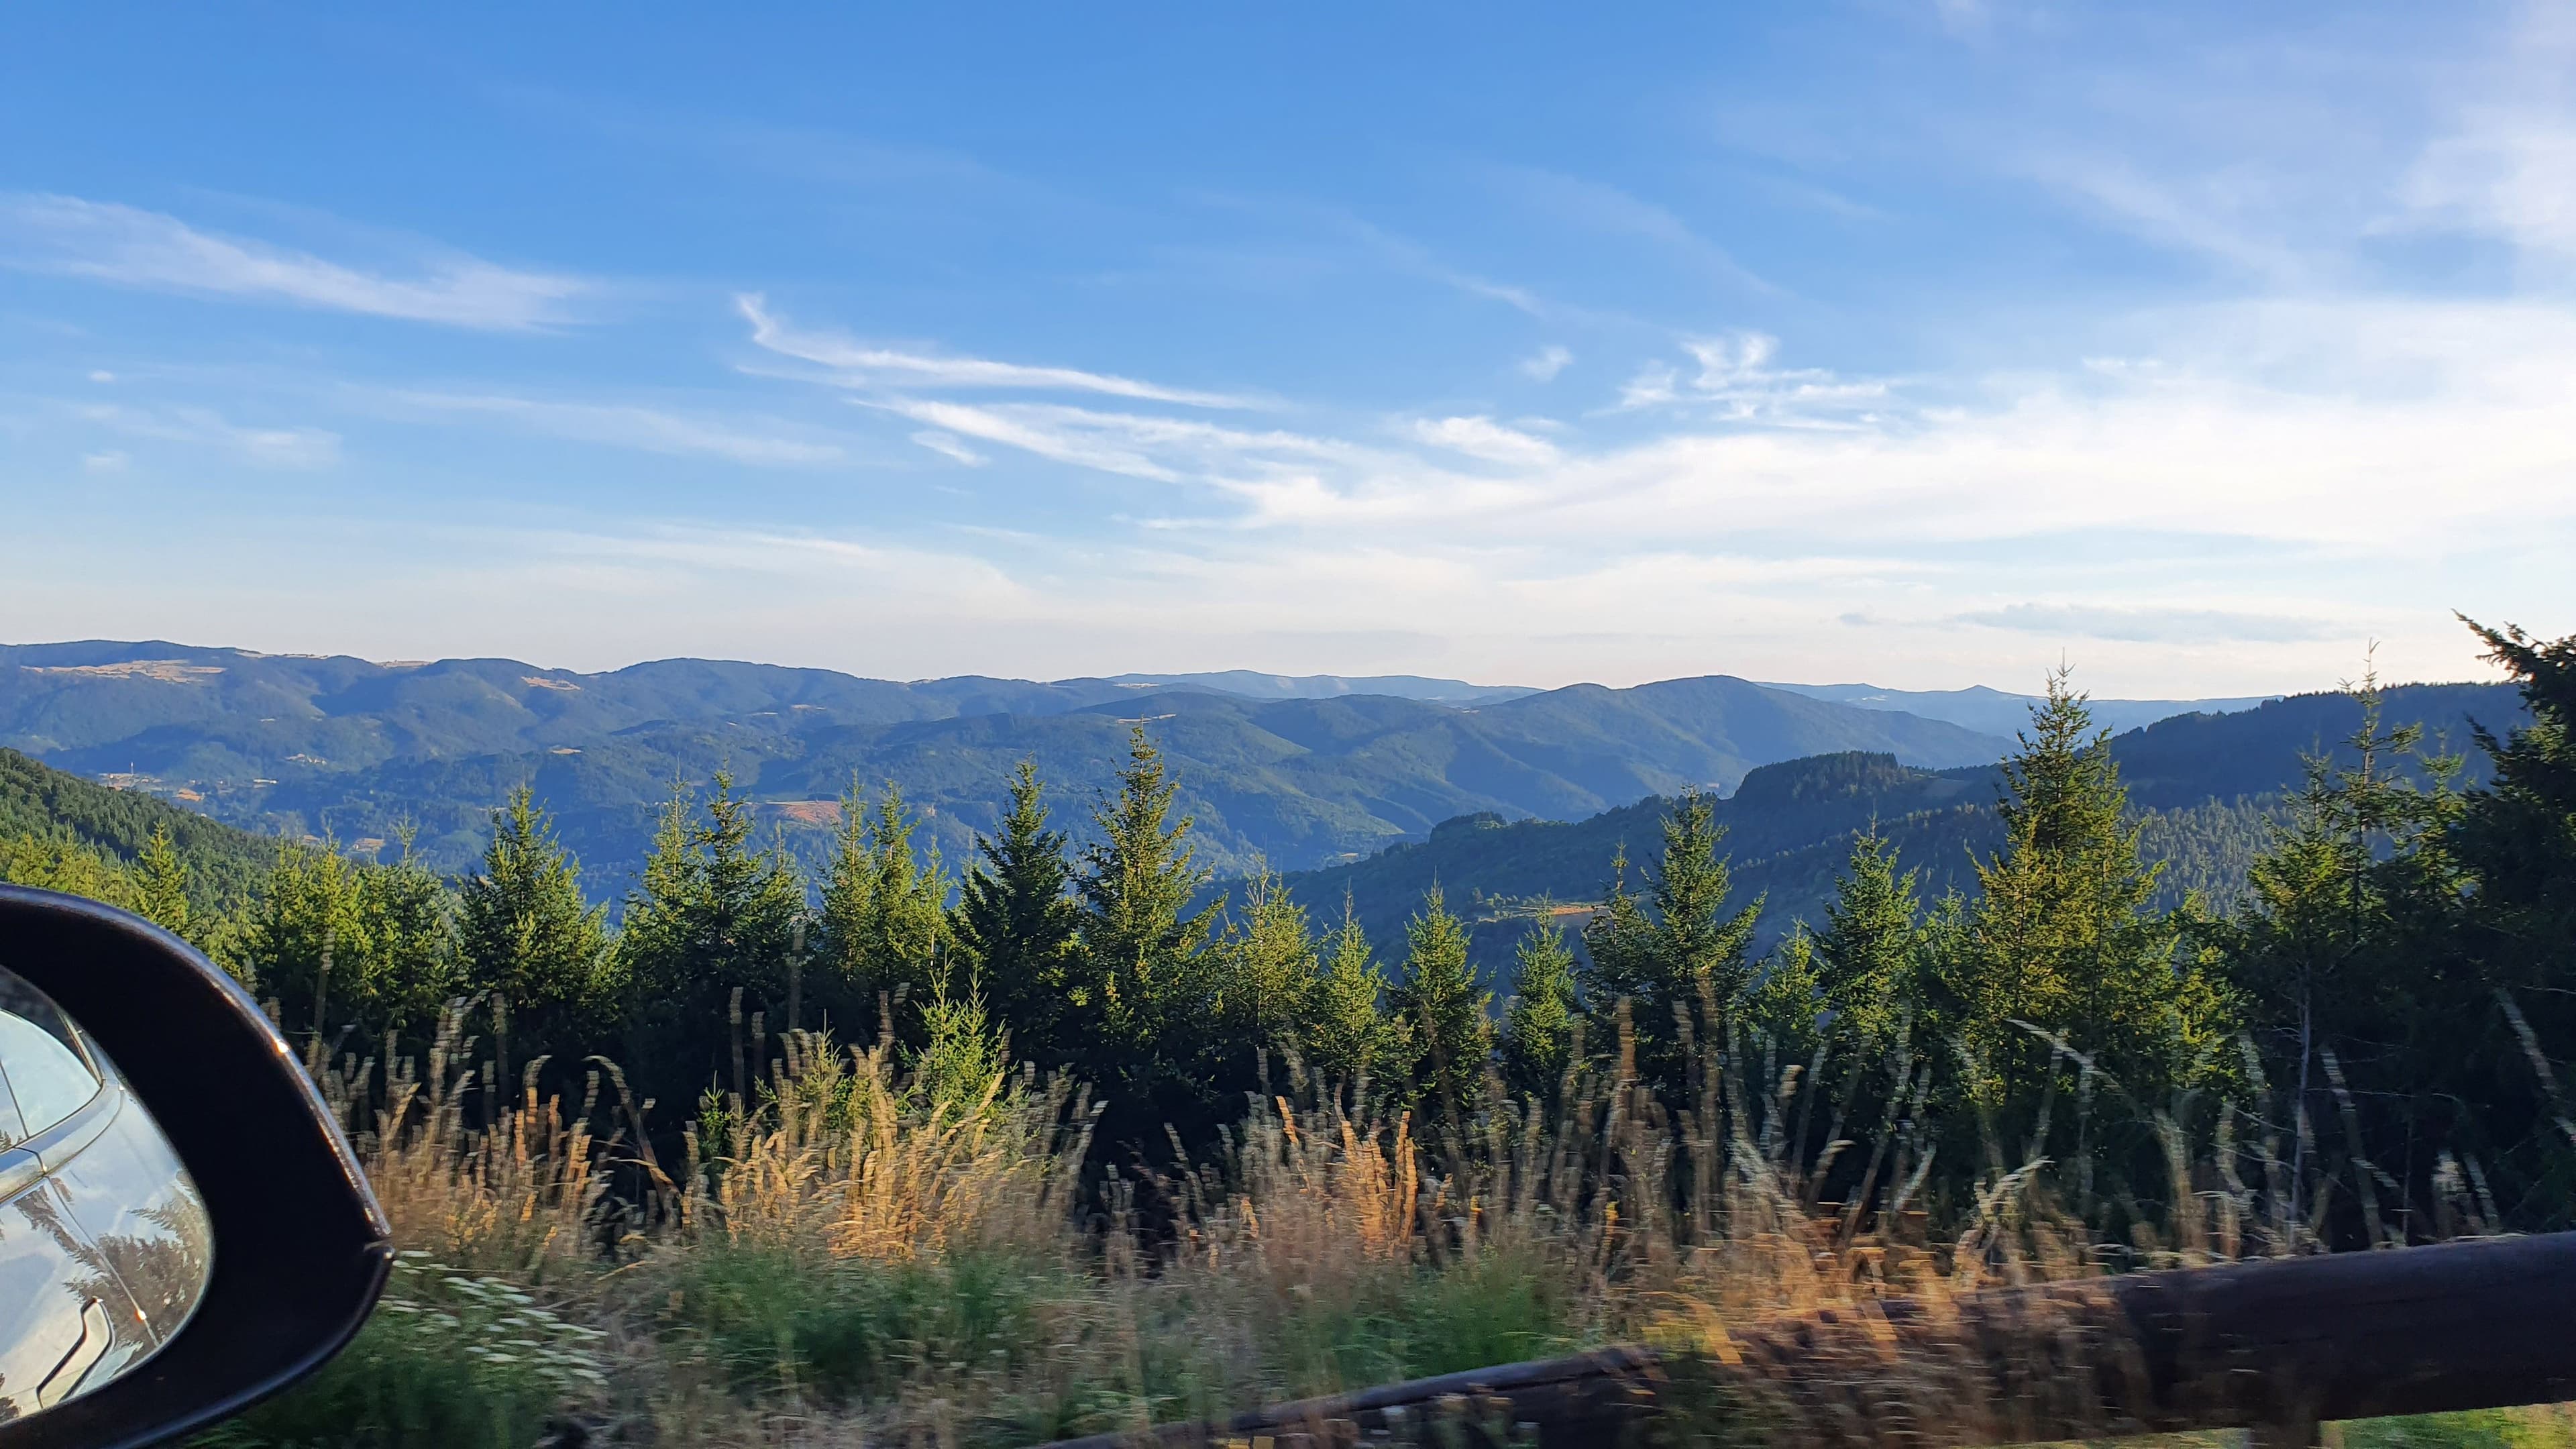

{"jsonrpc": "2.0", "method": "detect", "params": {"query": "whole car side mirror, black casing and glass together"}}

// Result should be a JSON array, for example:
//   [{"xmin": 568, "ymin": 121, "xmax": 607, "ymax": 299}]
[{"xmin": 0, "ymin": 884, "xmax": 394, "ymax": 1449}]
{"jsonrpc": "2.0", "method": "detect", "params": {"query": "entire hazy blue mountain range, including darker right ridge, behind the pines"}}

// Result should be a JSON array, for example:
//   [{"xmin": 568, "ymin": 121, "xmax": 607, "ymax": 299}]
[{"xmin": 0, "ymin": 642, "xmax": 2524, "ymax": 985}]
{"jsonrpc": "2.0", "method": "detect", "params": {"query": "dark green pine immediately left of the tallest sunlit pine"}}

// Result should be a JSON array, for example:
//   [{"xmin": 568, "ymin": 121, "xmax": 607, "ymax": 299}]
[{"xmin": 951, "ymin": 761, "xmax": 1100, "ymax": 1067}]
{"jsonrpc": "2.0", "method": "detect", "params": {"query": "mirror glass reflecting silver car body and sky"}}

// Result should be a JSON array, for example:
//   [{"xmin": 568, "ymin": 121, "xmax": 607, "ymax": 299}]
[{"xmin": 0, "ymin": 967, "xmax": 214, "ymax": 1421}]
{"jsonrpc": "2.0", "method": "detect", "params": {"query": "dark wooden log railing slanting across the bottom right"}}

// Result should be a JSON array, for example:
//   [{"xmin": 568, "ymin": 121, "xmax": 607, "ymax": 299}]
[{"xmin": 1049, "ymin": 1232, "xmax": 2576, "ymax": 1449}]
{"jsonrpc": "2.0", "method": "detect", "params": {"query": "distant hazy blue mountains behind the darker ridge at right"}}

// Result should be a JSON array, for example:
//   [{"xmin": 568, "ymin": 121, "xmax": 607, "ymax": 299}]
[{"xmin": 0, "ymin": 642, "xmax": 2004, "ymax": 895}]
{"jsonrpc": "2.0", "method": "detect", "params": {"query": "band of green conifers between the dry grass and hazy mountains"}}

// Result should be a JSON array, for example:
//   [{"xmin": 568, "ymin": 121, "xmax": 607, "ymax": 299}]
[{"xmin": 0, "ymin": 613, "xmax": 2576, "ymax": 1238}]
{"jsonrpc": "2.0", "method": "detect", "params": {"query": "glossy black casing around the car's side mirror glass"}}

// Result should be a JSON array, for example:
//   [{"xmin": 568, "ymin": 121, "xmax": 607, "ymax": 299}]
[{"xmin": 0, "ymin": 884, "xmax": 394, "ymax": 1449}]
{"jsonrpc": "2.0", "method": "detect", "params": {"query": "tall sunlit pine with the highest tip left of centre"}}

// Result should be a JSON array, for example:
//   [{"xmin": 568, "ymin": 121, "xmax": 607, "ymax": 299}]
[{"xmin": 1074, "ymin": 724, "xmax": 1218, "ymax": 1116}]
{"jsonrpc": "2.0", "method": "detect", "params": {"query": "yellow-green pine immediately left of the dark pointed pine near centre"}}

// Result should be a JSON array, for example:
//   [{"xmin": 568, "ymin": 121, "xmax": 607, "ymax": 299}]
[{"xmin": 816, "ymin": 784, "xmax": 948, "ymax": 1026}]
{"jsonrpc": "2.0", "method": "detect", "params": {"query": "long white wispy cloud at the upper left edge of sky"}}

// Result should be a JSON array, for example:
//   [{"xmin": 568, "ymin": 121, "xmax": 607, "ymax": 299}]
[{"xmin": 0, "ymin": 193, "xmax": 592, "ymax": 333}]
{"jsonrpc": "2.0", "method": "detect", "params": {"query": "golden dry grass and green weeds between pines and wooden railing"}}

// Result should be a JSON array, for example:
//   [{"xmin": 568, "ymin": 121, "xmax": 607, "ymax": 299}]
[{"xmin": 201, "ymin": 1013, "xmax": 2576, "ymax": 1449}]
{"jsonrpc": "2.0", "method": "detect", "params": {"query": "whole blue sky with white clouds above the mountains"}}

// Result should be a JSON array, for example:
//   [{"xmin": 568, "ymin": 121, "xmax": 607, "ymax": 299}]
[{"xmin": 0, "ymin": 0, "xmax": 2576, "ymax": 696}]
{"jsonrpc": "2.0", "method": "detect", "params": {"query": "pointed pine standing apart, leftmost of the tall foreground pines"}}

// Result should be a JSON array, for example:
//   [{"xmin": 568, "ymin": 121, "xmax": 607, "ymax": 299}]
[{"xmin": 456, "ymin": 784, "xmax": 608, "ymax": 1062}]
